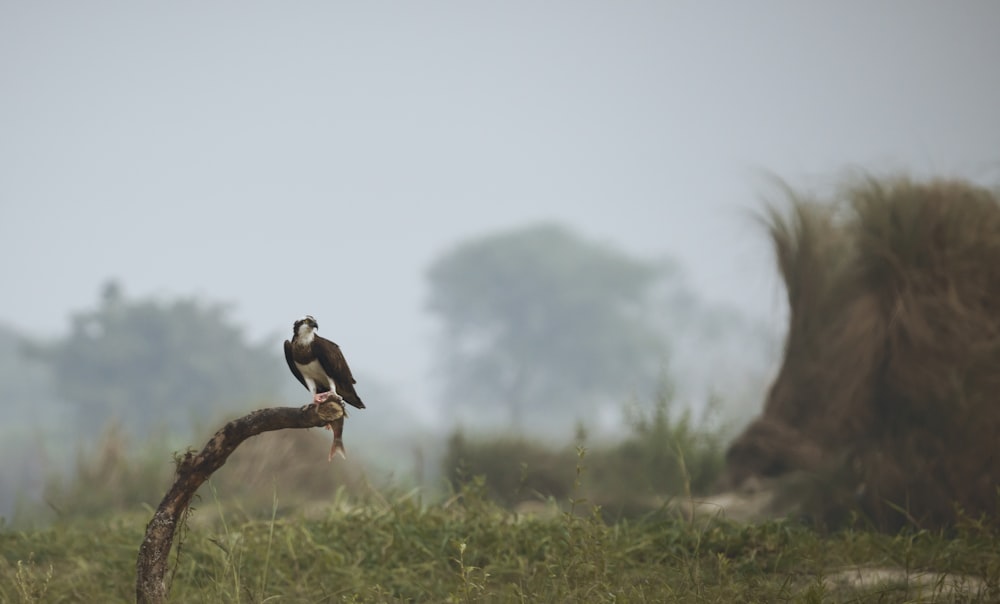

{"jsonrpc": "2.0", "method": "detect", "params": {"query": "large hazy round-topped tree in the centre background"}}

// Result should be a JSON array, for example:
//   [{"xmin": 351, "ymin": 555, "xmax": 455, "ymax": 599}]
[{"xmin": 428, "ymin": 223, "xmax": 673, "ymax": 425}]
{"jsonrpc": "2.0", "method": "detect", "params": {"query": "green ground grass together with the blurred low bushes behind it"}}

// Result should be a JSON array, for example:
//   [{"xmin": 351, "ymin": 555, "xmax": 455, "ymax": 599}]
[{"xmin": 0, "ymin": 376, "xmax": 1000, "ymax": 602}]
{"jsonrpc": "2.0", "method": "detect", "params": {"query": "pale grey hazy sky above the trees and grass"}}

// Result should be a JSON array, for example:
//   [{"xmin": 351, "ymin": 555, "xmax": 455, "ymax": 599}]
[{"xmin": 0, "ymin": 0, "xmax": 1000, "ymax": 410}]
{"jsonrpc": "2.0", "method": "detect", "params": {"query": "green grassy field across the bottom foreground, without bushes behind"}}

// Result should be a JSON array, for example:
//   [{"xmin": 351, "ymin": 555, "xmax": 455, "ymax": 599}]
[{"xmin": 0, "ymin": 482, "xmax": 1000, "ymax": 602}]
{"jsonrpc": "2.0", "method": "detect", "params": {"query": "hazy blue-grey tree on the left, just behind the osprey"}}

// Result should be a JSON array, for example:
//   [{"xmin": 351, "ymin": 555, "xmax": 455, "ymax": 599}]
[{"xmin": 26, "ymin": 282, "xmax": 287, "ymax": 435}]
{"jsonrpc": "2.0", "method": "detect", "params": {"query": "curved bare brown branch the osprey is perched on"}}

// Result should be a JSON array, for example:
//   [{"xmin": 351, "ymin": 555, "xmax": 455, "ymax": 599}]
[{"xmin": 135, "ymin": 401, "xmax": 345, "ymax": 604}]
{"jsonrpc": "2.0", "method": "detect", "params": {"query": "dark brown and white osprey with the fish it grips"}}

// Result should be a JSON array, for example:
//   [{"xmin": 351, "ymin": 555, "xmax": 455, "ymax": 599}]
[{"xmin": 285, "ymin": 315, "xmax": 365, "ymax": 459}]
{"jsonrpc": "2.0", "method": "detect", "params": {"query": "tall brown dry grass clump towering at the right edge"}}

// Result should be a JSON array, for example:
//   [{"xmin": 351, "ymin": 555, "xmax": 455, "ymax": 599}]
[{"xmin": 727, "ymin": 172, "xmax": 1000, "ymax": 529}]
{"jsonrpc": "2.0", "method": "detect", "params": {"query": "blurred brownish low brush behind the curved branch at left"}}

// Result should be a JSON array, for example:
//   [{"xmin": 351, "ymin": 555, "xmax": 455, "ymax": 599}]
[{"xmin": 13, "ymin": 412, "xmax": 366, "ymax": 525}]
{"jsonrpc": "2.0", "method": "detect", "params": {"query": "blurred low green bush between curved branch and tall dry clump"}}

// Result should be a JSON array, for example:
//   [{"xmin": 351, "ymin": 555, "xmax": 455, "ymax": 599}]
[{"xmin": 442, "ymin": 391, "xmax": 725, "ymax": 518}]
